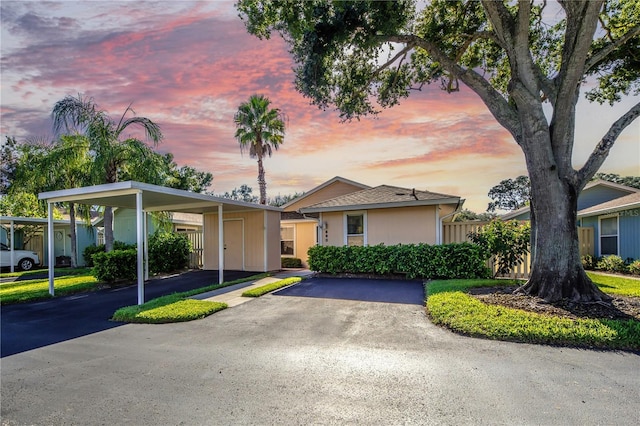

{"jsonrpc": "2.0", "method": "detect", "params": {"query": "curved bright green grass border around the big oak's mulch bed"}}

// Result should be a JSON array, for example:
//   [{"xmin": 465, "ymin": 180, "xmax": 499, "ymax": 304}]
[{"xmin": 426, "ymin": 277, "xmax": 640, "ymax": 351}]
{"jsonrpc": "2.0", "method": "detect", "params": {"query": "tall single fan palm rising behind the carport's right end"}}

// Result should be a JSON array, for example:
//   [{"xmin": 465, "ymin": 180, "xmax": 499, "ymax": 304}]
[{"xmin": 234, "ymin": 95, "xmax": 286, "ymax": 204}]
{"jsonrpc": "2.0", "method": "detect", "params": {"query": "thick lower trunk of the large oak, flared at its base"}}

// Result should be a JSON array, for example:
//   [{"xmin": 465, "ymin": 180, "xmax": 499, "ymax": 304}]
[{"xmin": 519, "ymin": 169, "xmax": 611, "ymax": 302}]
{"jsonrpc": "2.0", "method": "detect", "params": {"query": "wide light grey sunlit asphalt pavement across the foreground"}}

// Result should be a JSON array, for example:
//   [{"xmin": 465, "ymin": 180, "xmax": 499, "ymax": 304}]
[{"xmin": 1, "ymin": 281, "xmax": 640, "ymax": 425}]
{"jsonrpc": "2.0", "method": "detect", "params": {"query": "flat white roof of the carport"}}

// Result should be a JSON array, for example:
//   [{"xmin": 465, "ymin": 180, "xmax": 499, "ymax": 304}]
[{"xmin": 38, "ymin": 181, "xmax": 282, "ymax": 213}]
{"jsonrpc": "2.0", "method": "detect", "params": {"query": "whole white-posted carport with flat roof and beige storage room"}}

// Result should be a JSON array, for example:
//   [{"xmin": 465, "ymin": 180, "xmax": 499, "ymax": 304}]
[{"xmin": 39, "ymin": 181, "xmax": 281, "ymax": 304}]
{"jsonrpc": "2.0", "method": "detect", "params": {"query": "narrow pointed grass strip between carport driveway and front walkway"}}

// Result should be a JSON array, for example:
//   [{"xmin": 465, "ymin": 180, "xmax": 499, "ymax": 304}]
[{"xmin": 111, "ymin": 273, "xmax": 269, "ymax": 324}]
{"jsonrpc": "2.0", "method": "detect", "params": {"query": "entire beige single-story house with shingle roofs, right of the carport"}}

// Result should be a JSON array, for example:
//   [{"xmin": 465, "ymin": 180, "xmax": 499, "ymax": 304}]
[{"xmin": 281, "ymin": 177, "xmax": 464, "ymax": 261}]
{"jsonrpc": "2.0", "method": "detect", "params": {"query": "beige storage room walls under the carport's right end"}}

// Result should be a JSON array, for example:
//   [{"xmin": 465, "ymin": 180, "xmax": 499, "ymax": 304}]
[{"xmin": 203, "ymin": 210, "xmax": 280, "ymax": 271}]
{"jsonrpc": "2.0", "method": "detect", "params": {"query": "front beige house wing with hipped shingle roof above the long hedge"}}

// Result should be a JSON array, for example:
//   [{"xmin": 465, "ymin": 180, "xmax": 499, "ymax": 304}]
[{"xmin": 292, "ymin": 181, "xmax": 464, "ymax": 260}]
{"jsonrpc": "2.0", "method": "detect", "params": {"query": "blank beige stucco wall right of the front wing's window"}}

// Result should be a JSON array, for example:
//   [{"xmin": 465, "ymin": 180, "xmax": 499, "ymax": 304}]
[{"xmin": 367, "ymin": 206, "xmax": 436, "ymax": 245}]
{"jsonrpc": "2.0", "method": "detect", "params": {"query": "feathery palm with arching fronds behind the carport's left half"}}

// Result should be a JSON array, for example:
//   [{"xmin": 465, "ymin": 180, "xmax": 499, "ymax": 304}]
[{"xmin": 51, "ymin": 95, "xmax": 162, "ymax": 251}]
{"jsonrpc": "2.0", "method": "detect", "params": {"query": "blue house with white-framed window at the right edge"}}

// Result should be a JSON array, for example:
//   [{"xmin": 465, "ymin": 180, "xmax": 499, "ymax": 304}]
[{"xmin": 578, "ymin": 191, "xmax": 640, "ymax": 259}]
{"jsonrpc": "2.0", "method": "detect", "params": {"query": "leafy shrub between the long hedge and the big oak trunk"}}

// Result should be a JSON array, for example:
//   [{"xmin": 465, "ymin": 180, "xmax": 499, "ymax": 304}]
[{"xmin": 469, "ymin": 219, "xmax": 531, "ymax": 275}]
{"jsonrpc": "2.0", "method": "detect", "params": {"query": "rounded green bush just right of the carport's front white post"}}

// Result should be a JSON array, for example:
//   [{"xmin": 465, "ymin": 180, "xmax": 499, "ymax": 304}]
[{"xmin": 149, "ymin": 231, "xmax": 191, "ymax": 273}]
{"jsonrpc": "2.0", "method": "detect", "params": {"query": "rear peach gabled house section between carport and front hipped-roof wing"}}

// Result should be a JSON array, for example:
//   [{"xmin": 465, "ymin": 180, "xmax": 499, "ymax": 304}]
[{"xmin": 280, "ymin": 176, "xmax": 369, "ymax": 267}]
